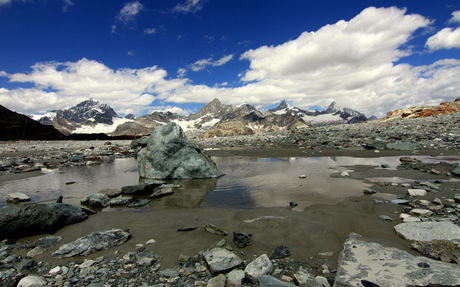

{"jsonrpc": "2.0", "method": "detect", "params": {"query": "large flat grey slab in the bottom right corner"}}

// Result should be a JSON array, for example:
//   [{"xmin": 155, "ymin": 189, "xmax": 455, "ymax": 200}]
[{"xmin": 334, "ymin": 234, "xmax": 460, "ymax": 287}]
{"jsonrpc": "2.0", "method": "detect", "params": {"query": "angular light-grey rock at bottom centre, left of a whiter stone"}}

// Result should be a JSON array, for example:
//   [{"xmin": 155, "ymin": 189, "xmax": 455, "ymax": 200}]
[{"xmin": 203, "ymin": 247, "xmax": 243, "ymax": 274}]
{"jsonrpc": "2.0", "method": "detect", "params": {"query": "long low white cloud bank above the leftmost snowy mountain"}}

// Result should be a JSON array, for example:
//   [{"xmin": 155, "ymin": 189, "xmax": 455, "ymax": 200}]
[{"xmin": 0, "ymin": 59, "xmax": 187, "ymax": 114}]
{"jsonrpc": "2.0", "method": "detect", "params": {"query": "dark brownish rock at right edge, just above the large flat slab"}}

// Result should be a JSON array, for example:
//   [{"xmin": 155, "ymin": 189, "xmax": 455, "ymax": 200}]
[{"xmin": 411, "ymin": 240, "xmax": 460, "ymax": 264}]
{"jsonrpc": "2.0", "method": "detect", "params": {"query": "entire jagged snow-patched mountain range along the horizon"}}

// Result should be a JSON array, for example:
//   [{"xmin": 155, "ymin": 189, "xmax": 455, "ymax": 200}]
[{"xmin": 33, "ymin": 99, "xmax": 368, "ymax": 137}]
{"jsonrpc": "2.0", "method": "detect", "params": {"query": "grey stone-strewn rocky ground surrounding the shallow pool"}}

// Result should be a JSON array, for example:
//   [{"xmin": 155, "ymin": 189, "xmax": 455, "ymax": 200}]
[{"xmin": 0, "ymin": 114, "xmax": 460, "ymax": 286}]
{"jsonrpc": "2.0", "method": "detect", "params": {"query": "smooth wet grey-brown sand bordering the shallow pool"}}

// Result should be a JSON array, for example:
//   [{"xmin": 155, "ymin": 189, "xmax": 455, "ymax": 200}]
[{"xmin": 9, "ymin": 147, "xmax": 459, "ymax": 269}]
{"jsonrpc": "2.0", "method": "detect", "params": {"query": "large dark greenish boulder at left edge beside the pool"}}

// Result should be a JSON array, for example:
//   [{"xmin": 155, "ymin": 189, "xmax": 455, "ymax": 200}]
[{"xmin": 0, "ymin": 203, "xmax": 88, "ymax": 242}]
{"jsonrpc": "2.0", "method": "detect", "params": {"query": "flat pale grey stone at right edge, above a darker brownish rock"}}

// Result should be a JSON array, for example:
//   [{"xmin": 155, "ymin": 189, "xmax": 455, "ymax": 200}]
[{"xmin": 394, "ymin": 221, "xmax": 460, "ymax": 241}]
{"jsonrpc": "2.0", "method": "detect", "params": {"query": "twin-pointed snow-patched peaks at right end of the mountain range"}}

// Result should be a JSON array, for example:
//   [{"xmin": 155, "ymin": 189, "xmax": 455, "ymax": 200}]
[{"xmin": 268, "ymin": 101, "xmax": 368, "ymax": 126}]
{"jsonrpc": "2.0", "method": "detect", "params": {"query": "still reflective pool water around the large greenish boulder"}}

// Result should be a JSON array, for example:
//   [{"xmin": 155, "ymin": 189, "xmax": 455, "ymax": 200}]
[{"xmin": 0, "ymin": 156, "xmax": 458, "ymax": 211}]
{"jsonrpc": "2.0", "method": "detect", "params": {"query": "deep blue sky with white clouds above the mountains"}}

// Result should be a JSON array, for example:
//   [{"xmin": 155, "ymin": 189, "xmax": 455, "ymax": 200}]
[{"xmin": 0, "ymin": 0, "xmax": 460, "ymax": 117}]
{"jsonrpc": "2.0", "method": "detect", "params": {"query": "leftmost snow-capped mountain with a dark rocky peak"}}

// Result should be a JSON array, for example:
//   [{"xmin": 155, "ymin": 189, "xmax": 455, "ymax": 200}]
[{"xmin": 33, "ymin": 99, "xmax": 130, "ymax": 135}]
